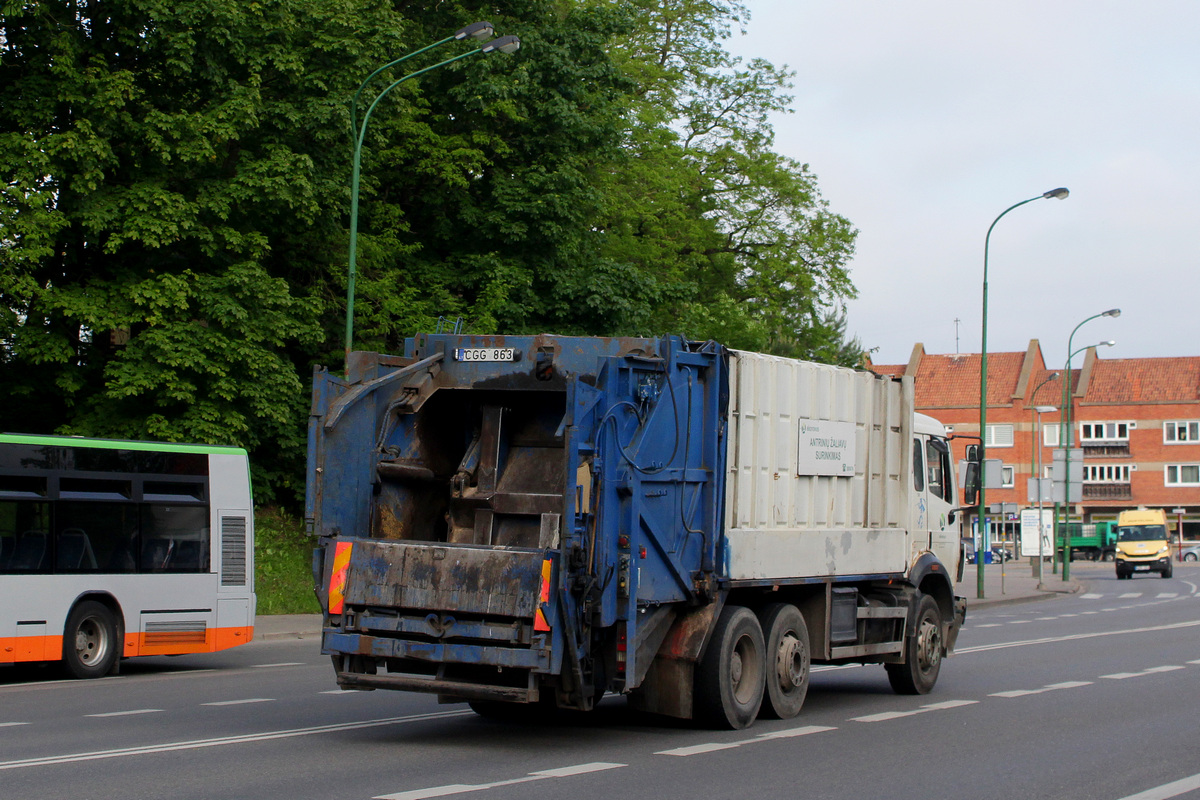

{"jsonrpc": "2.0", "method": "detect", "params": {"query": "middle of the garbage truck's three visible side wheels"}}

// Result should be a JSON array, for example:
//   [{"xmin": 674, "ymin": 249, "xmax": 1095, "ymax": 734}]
[{"xmin": 758, "ymin": 603, "xmax": 812, "ymax": 720}]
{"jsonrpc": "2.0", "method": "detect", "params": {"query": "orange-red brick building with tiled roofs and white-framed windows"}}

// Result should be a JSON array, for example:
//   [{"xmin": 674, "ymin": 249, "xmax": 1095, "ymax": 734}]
[{"xmin": 870, "ymin": 339, "xmax": 1200, "ymax": 554}]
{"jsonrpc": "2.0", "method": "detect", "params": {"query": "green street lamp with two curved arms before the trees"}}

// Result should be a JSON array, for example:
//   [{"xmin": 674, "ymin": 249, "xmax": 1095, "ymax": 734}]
[{"xmin": 344, "ymin": 22, "xmax": 521, "ymax": 374}]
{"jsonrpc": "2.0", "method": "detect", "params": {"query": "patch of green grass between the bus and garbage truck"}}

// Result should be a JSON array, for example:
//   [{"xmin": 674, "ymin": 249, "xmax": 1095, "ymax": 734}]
[{"xmin": 254, "ymin": 509, "xmax": 320, "ymax": 614}]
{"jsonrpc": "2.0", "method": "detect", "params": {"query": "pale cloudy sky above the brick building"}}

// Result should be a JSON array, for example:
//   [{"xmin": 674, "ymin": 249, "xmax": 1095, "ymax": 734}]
[{"xmin": 726, "ymin": 0, "xmax": 1200, "ymax": 368}]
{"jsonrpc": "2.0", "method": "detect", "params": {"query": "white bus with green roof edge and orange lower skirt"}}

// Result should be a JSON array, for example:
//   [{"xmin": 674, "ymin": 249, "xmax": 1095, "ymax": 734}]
[{"xmin": 0, "ymin": 434, "xmax": 256, "ymax": 678}]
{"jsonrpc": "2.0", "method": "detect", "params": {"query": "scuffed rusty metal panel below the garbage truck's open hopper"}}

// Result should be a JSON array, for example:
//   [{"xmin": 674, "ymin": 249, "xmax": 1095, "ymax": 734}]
[{"xmin": 346, "ymin": 540, "xmax": 542, "ymax": 618}]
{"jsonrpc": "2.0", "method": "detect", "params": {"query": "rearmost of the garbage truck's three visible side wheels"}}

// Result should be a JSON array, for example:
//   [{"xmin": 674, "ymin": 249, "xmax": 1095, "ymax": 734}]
[{"xmin": 695, "ymin": 606, "xmax": 767, "ymax": 728}]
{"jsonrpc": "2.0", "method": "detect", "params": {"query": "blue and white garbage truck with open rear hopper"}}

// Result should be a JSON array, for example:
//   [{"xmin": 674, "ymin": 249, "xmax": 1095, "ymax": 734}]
[{"xmin": 306, "ymin": 333, "xmax": 966, "ymax": 728}]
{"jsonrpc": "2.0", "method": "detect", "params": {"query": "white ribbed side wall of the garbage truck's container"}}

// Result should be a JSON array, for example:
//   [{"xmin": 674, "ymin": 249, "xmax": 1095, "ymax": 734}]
[{"xmin": 726, "ymin": 350, "xmax": 913, "ymax": 579}]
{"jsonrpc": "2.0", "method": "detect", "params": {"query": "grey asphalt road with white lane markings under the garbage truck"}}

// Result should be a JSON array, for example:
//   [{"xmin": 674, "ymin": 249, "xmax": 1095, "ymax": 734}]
[{"xmin": 0, "ymin": 565, "xmax": 1200, "ymax": 800}]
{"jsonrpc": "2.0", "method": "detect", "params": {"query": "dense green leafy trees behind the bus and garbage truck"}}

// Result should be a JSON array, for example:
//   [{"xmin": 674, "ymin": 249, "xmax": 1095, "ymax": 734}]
[{"xmin": 0, "ymin": 0, "xmax": 857, "ymax": 520}]
